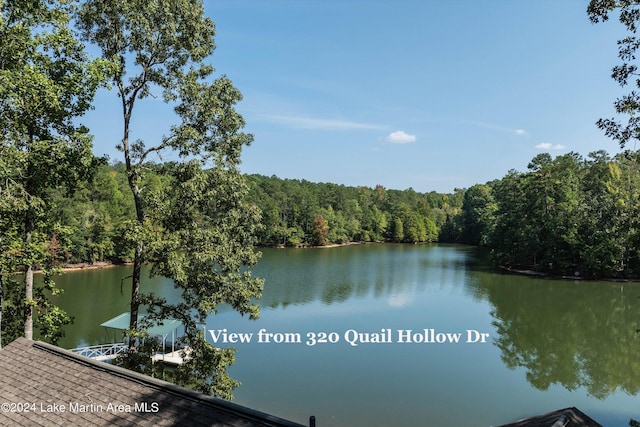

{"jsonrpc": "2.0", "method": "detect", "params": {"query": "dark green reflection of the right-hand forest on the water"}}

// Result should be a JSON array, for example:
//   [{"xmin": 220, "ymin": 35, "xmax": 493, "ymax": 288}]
[{"xmin": 478, "ymin": 275, "xmax": 640, "ymax": 399}]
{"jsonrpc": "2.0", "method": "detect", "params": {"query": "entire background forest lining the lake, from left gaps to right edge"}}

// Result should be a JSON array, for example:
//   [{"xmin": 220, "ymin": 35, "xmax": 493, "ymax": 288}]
[{"xmin": 46, "ymin": 151, "xmax": 640, "ymax": 278}]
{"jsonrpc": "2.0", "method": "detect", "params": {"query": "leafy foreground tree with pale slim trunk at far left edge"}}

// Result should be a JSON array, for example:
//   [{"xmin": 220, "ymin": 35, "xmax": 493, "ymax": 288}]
[{"xmin": 0, "ymin": 0, "xmax": 105, "ymax": 339}]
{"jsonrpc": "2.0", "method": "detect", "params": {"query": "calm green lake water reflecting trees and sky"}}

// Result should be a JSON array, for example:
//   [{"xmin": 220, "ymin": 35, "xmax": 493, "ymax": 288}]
[{"xmin": 48, "ymin": 244, "xmax": 640, "ymax": 427}]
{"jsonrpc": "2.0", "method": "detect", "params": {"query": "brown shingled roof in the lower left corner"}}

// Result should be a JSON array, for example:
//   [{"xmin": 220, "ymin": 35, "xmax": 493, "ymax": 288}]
[{"xmin": 0, "ymin": 338, "xmax": 303, "ymax": 427}]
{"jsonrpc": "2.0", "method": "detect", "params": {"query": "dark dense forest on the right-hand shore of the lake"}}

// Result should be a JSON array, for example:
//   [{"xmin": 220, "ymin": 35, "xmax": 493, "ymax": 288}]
[{"xmin": 442, "ymin": 151, "xmax": 640, "ymax": 278}]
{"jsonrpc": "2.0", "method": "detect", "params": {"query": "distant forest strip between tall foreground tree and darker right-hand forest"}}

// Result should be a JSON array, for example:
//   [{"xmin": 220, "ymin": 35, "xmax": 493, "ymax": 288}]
[{"xmin": 246, "ymin": 175, "xmax": 450, "ymax": 246}]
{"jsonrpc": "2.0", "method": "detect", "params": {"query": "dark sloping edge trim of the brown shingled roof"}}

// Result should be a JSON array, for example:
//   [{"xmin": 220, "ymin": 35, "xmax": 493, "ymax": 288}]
[{"xmin": 30, "ymin": 337, "xmax": 306, "ymax": 427}]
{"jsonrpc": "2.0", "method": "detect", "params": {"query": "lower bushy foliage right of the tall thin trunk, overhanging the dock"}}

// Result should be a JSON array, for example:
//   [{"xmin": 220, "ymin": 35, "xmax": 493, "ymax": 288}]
[{"xmin": 146, "ymin": 160, "xmax": 262, "ymax": 398}]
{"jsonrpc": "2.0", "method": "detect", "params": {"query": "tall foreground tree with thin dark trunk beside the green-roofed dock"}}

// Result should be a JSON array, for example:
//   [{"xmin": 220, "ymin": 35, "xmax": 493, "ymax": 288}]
[{"xmin": 79, "ymin": 0, "xmax": 262, "ymax": 398}]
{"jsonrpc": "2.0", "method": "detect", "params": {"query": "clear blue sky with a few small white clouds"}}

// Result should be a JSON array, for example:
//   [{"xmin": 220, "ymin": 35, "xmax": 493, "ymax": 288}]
[{"xmin": 84, "ymin": 0, "xmax": 634, "ymax": 192}]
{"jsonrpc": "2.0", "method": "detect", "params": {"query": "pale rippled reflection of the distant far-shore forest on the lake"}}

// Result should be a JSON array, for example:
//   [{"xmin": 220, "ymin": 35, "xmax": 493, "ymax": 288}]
[{"xmin": 253, "ymin": 244, "xmax": 469, "ymax": 308}]
